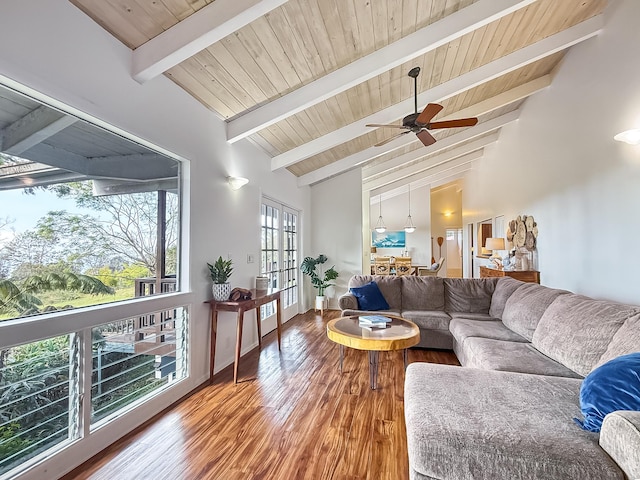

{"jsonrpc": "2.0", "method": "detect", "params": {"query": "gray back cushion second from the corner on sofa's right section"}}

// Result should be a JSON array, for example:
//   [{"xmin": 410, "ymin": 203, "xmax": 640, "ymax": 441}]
[{"xmin": 501, "ymin": 283, "xmax": 569, "ymax": 341}]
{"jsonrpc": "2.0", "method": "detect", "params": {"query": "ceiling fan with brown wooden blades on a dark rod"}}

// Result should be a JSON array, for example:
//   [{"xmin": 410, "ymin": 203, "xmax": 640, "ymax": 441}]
[{"xmin": 366, "ymin": 67, "xmax": 478, "ymax": 147}]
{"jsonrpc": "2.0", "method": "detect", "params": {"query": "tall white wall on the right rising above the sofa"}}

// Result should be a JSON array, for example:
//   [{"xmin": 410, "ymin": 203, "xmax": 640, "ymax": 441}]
[{"xmin": 463, "ymin": 0, "xmax": 640, "ymax": 304}]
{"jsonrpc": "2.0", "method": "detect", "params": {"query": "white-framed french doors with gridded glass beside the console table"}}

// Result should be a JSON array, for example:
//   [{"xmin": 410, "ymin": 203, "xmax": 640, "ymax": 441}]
[{"xmin": 260, "ymin": 198, "xmax": 299, "ymax": 331}]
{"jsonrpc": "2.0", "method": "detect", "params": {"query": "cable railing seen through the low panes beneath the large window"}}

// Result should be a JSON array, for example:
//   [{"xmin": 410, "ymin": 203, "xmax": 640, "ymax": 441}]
[{"xmin": 0, "ymin": 300, "xmax": 189, "ymax": 479}]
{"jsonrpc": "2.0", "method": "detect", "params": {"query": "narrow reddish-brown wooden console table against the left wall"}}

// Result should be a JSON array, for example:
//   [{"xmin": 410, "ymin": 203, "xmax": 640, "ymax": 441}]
[{"xmin": 205, "ymin": 289, "xmax": 282, "ymax": 384}]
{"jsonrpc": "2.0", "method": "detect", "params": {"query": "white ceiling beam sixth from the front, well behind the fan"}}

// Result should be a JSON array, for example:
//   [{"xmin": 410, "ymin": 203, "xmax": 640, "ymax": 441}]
[{"xmin": 362, "ymin": 132, "xmax": 500, "ymax": 190}]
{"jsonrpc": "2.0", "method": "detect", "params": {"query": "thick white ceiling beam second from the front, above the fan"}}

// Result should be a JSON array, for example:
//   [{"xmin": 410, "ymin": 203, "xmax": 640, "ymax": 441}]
[{"xmin": 227, "ymin": 0, "xmax": 535, "ymax": 143}]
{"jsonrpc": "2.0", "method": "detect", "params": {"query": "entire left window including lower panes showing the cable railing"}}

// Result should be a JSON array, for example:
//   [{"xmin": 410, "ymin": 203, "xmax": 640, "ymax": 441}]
[{"xmin": 0, "ymin": 80, "xmax": 189, "ymax": 478}]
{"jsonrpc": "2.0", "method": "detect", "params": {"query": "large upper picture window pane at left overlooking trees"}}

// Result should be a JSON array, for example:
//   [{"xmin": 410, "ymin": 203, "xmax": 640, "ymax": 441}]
[{"xmin": 0, "ymin": 85, "xmax": 180, "ymax": 321}]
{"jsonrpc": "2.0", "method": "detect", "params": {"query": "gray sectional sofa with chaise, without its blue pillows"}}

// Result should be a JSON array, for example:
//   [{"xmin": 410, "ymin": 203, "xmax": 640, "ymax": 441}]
[{"xmin": 339, "ymin": 275, "xmax": 640, "ymax": 480}]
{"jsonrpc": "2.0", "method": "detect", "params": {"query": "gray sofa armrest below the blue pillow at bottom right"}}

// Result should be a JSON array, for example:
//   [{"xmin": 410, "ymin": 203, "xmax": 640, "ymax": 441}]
[{"xmin": 600, "ymin": 411, "xmax": 640, "ymax": 479}]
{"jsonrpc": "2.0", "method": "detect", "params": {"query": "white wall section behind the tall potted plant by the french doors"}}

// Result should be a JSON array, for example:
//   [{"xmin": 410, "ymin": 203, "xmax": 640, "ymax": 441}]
[{"xmin": 305, "ymin": 169, "xmax": 362, "ymax": 308}]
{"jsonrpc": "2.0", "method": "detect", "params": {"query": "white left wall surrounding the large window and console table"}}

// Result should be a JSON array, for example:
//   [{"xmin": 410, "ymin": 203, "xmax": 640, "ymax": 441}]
[{"xmin": 0, "ymin": 0, "xmax": 310, "ymax": 478}]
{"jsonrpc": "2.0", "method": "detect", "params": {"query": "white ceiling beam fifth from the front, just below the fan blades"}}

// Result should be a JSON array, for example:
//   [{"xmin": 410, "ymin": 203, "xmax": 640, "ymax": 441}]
[{"xmin": 362, "ymin": 110, "xmax": 520, "ymax": 182}]
